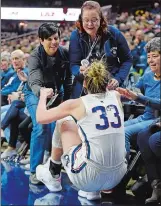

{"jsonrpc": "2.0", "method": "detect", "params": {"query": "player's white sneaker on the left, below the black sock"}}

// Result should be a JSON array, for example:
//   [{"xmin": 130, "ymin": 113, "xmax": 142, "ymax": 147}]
[{"xmin": 36, "ymin": 159, "xmax": 62, "ymax": 192}]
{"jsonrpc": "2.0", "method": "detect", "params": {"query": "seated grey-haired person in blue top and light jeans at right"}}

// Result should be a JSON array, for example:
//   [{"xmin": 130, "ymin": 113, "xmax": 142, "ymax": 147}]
[{"xmin": 125, "ymin": 37, "xmax": 160, "ymax": 158}]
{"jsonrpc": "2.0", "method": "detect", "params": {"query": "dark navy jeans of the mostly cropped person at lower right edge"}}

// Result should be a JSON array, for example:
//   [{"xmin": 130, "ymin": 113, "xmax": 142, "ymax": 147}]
[{"xmin": 137, "ymin": 127, "xmax": 161, "ymax": 182}]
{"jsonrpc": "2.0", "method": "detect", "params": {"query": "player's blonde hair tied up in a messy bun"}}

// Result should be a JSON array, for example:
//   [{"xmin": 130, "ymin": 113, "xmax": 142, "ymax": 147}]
[{"xmin": 84, "ymin": 60, "xmax": 111, "ymax": 94}]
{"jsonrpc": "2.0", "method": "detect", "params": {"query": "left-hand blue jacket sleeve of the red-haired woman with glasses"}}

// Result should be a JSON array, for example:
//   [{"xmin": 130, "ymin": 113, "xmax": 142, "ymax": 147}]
[{"xmin": 69, "ymin": 30, "xmax": 83, "ymax": 80}]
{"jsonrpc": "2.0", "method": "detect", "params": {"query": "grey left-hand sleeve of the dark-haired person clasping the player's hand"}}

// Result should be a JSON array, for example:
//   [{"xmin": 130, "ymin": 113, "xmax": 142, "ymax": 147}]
[{"xmin": 28, "ymin": 54, "xmax": 44, "ymax": 97}]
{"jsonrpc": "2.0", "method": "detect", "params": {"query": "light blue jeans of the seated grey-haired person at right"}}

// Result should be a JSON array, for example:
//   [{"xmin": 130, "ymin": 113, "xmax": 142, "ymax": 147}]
[{"xmin": 124, "ymin": 116, "xmax": 154, "ymax": 156}]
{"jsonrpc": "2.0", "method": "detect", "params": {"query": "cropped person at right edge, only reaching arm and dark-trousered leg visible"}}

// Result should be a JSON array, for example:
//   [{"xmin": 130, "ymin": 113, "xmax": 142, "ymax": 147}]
[{"xmin": 117, "ymin": 88, "xmax": 161, "ymax": 204}]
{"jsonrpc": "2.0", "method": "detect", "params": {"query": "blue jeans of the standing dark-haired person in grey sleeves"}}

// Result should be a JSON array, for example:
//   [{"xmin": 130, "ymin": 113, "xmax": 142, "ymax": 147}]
[{"xmin": 24, "ymin": 89, "xmax": 55, "ymax": 173}]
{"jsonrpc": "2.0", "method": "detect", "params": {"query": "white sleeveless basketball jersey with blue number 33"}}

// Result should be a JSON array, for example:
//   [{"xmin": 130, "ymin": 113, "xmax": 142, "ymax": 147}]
[{"xmin": 78, "ymin": 91, "xmax": 125, "ymax": 167}]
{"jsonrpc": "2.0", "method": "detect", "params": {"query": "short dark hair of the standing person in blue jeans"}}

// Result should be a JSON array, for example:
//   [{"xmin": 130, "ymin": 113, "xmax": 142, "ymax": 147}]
[{"xmin": 38, "ymin": 23, "xmax": 60, "ymax": 41}]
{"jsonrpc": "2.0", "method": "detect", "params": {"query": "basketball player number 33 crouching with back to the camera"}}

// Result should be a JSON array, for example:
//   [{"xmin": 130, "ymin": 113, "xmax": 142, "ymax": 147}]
[{"xmin": 36, "ymin": 61, "xmax": 127, "ymax": 200}]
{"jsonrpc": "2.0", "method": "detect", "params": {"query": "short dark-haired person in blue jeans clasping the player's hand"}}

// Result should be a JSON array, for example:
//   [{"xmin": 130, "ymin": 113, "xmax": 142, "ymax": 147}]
[{"xmin": 25, "ymin": 23, "xmax": 72, "ymax": 184}]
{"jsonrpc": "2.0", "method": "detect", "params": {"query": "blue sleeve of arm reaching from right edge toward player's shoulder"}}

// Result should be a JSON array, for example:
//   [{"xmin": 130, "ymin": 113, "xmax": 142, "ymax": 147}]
[{"xmin": 136, "ymin": 95, "xmax": 161, "ymax": 110}]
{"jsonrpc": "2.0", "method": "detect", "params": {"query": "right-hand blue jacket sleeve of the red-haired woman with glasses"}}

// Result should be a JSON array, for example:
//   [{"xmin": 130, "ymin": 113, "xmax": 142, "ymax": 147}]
[{"xmin": 115, "ymin": 30, "xmax": 132, "ymax": 83}]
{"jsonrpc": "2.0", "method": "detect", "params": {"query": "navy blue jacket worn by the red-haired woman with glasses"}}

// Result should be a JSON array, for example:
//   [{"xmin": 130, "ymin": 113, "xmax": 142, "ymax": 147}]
[{"xmin": 69, "ymin": 26, "xmax": 132, "ymax": 98}]
